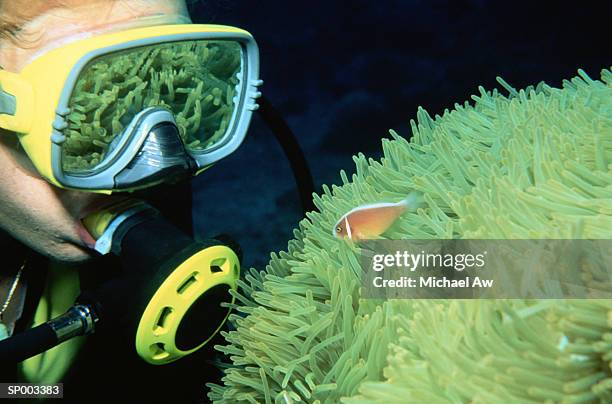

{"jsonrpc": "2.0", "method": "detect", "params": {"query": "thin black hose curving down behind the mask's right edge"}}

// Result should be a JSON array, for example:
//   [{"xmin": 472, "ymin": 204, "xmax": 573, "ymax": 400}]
[{"xmin": 257, "ymin": 96, "xmax": 315, "ymax": 213}]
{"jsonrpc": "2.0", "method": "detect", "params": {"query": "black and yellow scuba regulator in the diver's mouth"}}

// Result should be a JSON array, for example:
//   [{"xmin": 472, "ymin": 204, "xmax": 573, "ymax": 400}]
[{"xmin": 79, "ymin": 200, "xmax": 240, "ymax": 365}]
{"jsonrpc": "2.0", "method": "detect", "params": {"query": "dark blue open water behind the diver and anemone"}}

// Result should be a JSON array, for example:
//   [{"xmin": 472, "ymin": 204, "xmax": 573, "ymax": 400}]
[{"xmin": 190, "ymin": 0, "xmax": 612, "ymax": 269}]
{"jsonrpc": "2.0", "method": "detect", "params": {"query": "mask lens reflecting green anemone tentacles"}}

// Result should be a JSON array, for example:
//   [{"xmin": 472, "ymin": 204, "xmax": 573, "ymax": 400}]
[{"xmin": 62, "ymin": 40, "xmax": 244, "ymax": 174}]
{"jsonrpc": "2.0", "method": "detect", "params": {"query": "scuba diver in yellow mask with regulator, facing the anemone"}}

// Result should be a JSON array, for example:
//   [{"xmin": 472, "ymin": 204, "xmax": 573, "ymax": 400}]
[{"xmin": 0, "ymin": 0, "xmax": 313, "ymax": 402}]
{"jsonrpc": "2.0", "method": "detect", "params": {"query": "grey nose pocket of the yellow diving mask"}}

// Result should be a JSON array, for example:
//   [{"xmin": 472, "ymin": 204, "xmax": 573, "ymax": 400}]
[{"xmin": 115, "ymin": 107, "xmax": 196, "ymax": 189}]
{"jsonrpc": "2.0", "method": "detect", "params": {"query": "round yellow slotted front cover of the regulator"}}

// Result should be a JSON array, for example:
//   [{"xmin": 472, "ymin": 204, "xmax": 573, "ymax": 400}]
[{"xmin": 136, "ymin": 245, "xmax": 240, "ymax": 365}]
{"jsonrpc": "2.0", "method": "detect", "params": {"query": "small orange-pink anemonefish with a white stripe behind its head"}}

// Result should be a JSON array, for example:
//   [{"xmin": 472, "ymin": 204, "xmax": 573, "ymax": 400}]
[{"xmin": 332, "ymin": 192, "xmax": 422, "ymax": 241}]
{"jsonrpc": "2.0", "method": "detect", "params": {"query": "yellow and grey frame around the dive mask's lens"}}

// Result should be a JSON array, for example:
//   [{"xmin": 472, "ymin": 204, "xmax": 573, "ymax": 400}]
[{"xmin": 0, "ymin": 24, "xmax": 262, "ymax": 193}]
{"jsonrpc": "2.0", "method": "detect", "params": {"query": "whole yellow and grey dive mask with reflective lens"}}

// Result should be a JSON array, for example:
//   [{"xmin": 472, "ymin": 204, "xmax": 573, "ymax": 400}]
[{"xmin": 0, "ymin": 24, "xmax": 262, "ymax": 193}]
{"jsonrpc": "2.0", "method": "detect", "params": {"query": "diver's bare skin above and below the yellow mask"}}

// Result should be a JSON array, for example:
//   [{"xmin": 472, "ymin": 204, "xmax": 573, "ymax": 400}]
[{"xmin": 0, "ymin": 0, "xmax": 189, "ymax": 262}]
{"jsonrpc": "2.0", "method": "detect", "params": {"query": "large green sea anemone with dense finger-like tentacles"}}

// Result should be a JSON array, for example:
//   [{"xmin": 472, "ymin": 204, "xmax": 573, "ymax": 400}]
[{"xmin": 209, "ymin": 70, "xmax": 612, "ymax": 403}]
